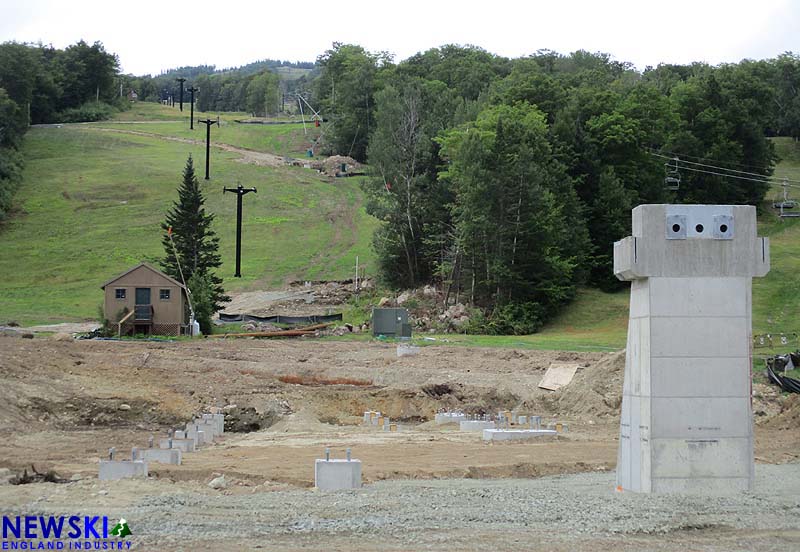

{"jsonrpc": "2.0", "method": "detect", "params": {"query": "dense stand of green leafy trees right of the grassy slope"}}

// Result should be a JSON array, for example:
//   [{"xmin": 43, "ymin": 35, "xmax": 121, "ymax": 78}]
[{"xmin": 312, "ymin": 44, "xmax": 800, "ymax": 333}]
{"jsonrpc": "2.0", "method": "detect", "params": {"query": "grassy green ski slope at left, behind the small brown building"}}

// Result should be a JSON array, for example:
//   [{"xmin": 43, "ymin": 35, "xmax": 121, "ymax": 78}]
[{"xmin": 0, "ymin": 105, "xmax": 376, "ymax": 324}]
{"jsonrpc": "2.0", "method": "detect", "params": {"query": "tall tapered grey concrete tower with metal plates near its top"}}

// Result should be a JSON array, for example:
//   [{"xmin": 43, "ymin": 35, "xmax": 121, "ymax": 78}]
[{"xmin": 614, "ymin": 205, "xmax": 769, "ymax": 493}]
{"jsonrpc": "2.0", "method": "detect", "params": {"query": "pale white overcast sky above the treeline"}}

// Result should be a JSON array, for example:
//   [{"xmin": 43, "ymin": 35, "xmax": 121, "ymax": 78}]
[{"xmin": 0, "ymin": 0, "xmax": 800, "ymax": 75}]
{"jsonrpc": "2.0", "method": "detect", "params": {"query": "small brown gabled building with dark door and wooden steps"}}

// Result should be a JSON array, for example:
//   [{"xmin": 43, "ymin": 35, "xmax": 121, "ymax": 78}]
[{"xmin": 101, "ymin": 263, "xmax": 189, "ymax": 335}]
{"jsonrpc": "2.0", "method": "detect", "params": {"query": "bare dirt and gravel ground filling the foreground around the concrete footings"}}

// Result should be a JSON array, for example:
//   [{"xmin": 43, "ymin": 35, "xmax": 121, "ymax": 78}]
[{"xmin": 0, "ymin": 337, "xmax": 800, "ymax": 550}]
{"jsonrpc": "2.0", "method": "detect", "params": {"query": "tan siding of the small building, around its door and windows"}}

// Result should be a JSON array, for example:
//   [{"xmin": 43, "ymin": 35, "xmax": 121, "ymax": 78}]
[{"xmin": 104, "ymin": 266, "xmax": 186, "ymax": 324}]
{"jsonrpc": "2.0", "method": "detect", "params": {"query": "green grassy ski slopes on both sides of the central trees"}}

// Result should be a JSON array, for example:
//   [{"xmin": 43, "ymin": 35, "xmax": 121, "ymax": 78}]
[{"xmin": 0, "ymin": 104, "xmax": 800, "ymax": 349}]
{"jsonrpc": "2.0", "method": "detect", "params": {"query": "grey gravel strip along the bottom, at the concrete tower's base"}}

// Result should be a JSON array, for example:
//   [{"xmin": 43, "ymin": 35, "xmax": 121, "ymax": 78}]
[{"xmin": 0, "ymin": 464, "xmax": 800, "ymax": 551}]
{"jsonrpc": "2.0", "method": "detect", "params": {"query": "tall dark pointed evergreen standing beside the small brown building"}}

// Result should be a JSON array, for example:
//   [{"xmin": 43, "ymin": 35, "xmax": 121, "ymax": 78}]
[{"xmin": 161, "ymin": 155, "xmax": 230, "ymax": 322}]
